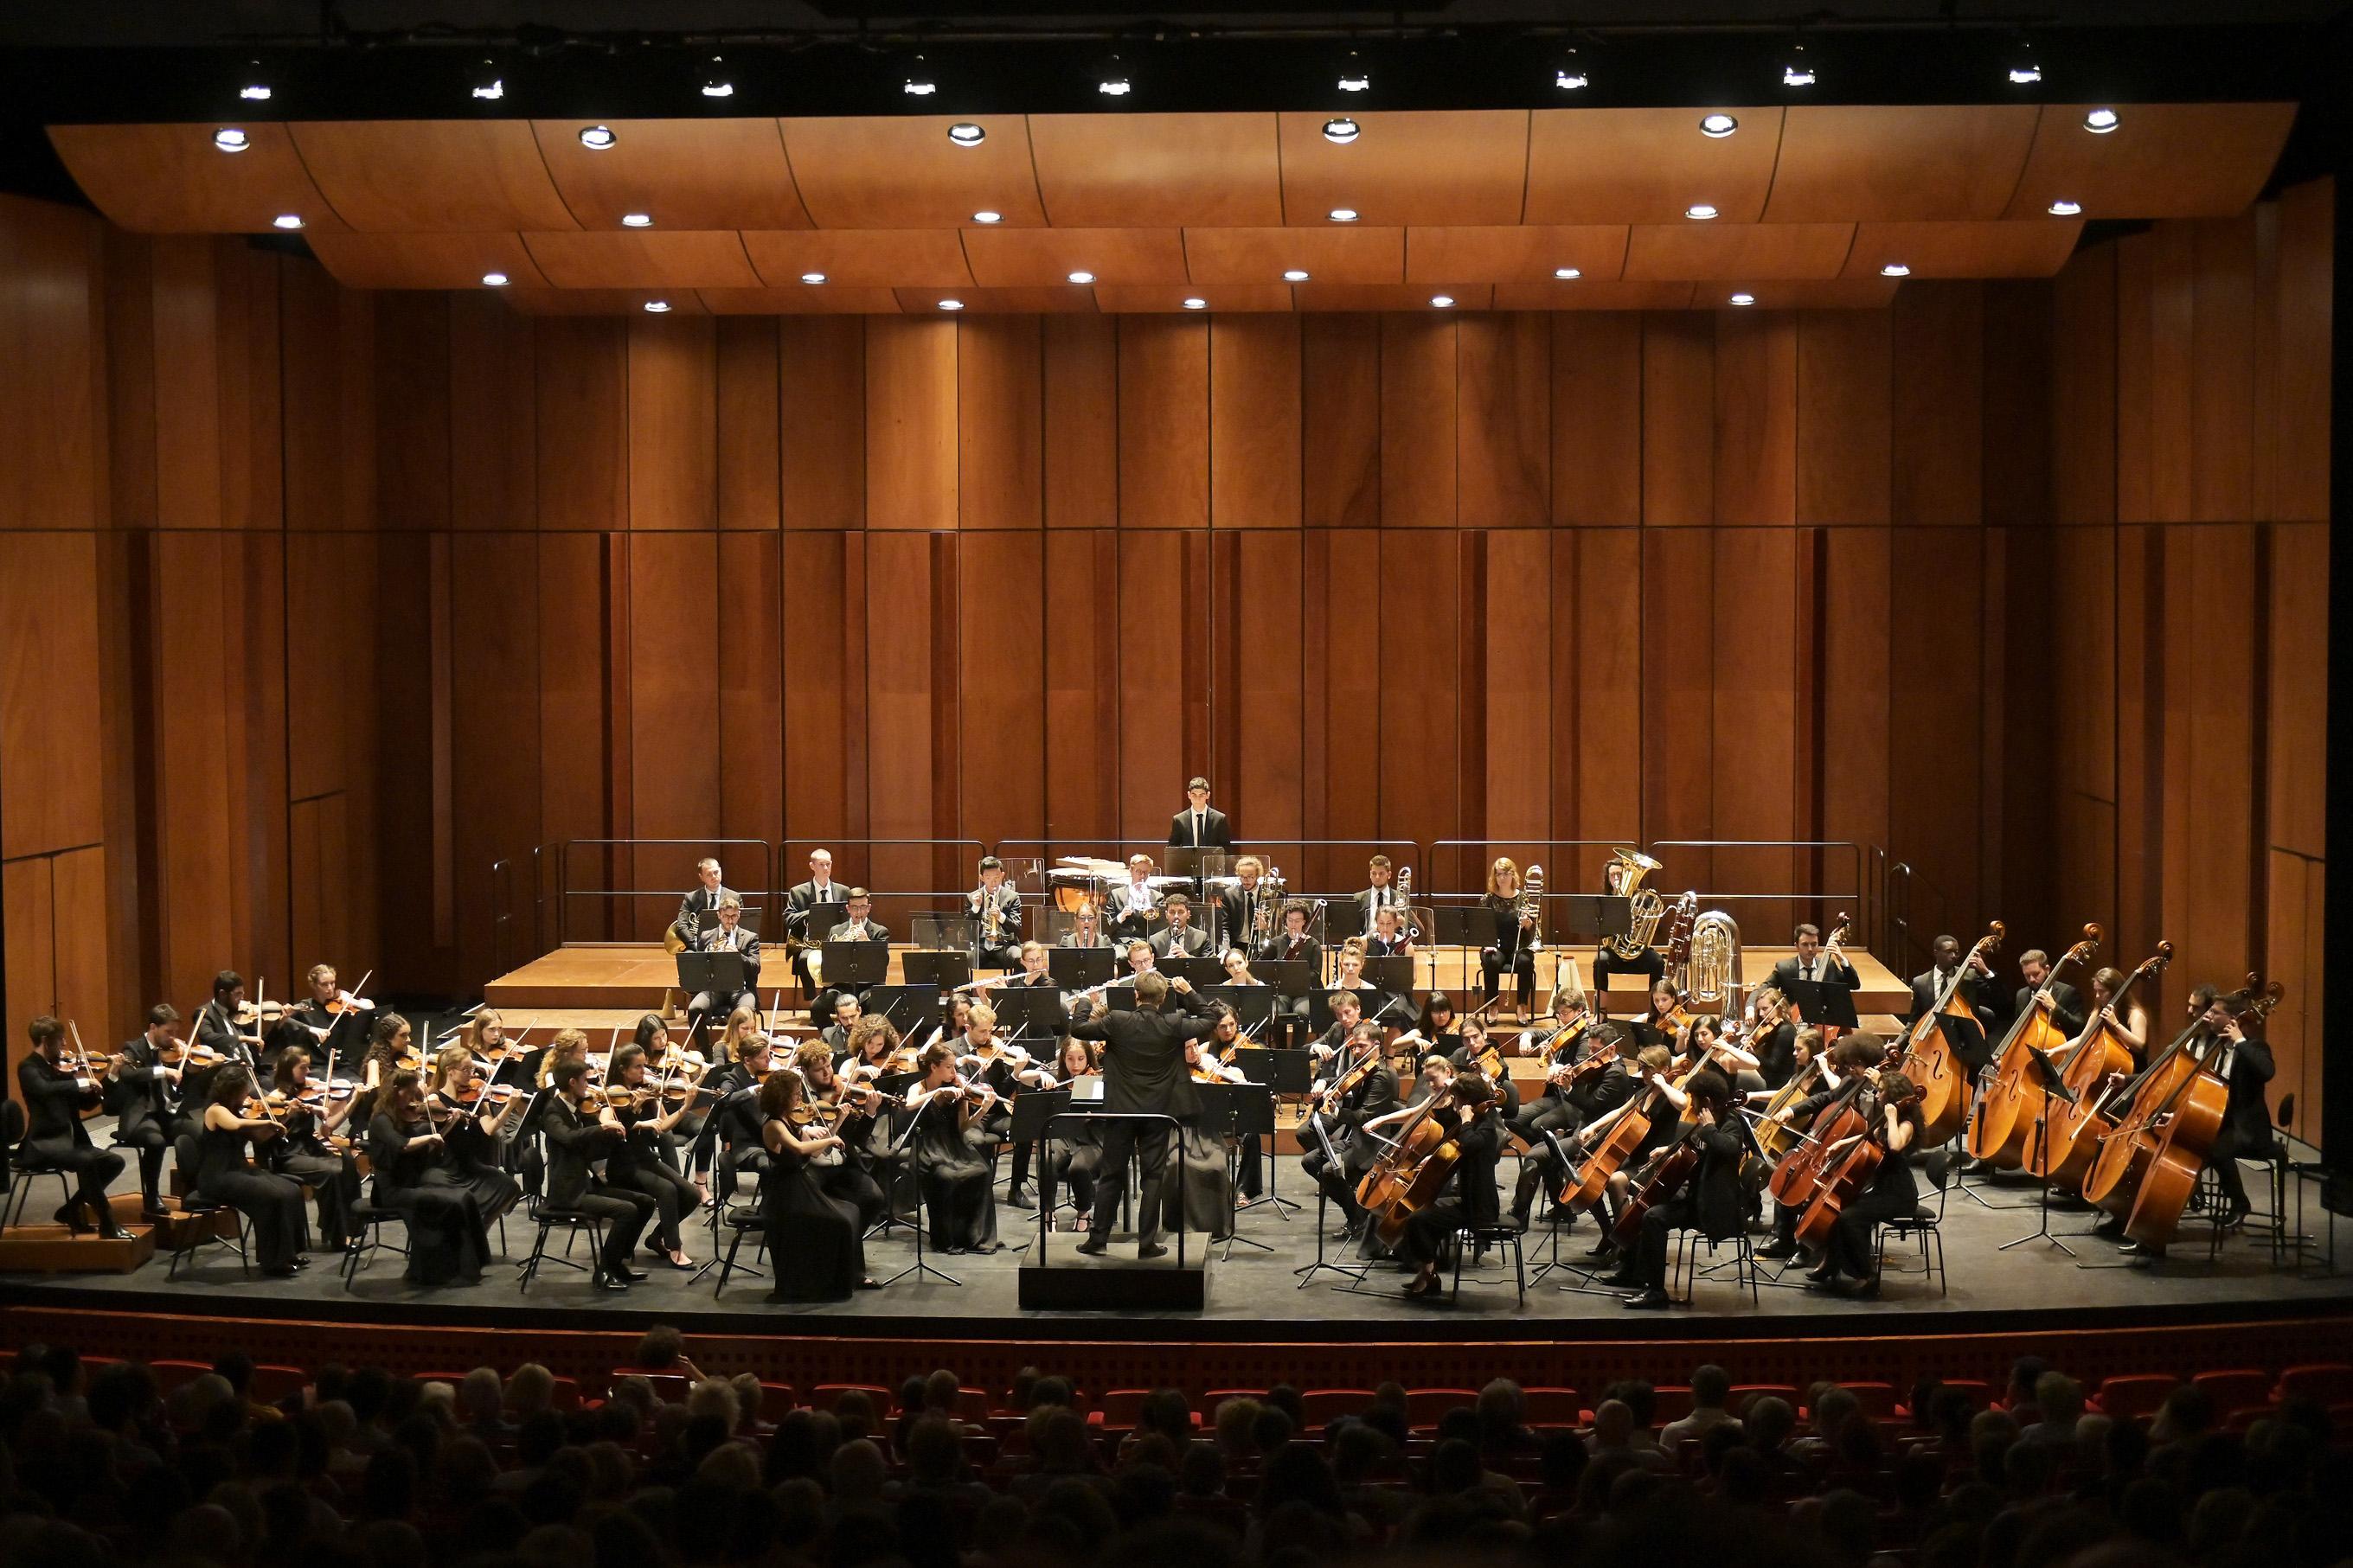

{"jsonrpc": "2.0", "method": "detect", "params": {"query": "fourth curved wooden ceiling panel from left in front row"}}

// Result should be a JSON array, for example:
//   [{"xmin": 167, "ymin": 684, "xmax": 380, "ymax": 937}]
[{"xmin": 784, "ymin": 115, "xmax": 1045, "ymax": 228}]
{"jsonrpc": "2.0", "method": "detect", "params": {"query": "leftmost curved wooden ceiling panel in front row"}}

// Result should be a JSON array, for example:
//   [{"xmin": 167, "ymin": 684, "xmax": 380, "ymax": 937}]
[{"xmin": 49, "ymin": 122, "xmax": 343, "ymax": 235}]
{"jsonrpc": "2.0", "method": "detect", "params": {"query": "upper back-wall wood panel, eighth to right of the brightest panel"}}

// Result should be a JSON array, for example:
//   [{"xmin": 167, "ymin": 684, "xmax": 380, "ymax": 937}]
[{"xmin": 1553, "ymin": 313, "xmax": 1643, "ymax": 524}]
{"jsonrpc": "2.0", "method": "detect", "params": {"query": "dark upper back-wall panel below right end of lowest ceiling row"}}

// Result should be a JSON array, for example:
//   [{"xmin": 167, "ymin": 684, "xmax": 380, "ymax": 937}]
[{"xmin": 1798, "ymin": 310, "xmax": 1892, "ymax": 522}]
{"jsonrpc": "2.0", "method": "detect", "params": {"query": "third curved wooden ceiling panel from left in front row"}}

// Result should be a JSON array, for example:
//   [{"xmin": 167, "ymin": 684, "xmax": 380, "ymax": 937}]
[{"xmin": 532, "ymin": 120, "xmax": 810, "ymax": 230}]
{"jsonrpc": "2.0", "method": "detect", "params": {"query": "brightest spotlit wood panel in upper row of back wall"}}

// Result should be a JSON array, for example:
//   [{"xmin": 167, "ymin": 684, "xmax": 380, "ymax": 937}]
[{"xmin": 866, "ymin": 315, "xmax": 958, "ymax": 531}]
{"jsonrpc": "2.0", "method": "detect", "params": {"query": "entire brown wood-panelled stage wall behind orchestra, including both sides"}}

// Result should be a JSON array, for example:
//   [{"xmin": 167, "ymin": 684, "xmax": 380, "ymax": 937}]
[{"xmin": 0, "ymin": 183, "xmax": 2332, "ymax": 1133}]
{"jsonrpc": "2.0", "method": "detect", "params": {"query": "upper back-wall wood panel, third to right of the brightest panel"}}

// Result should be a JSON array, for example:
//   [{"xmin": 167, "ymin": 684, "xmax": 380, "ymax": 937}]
[{"xmin": 1120, "ymin": 315, "xmax": 1209, "ymax": 531}]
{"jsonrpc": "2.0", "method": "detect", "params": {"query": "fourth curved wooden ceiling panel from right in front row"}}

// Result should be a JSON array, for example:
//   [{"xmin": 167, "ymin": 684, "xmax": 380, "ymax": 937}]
[{"xmin": 1280, "ymin": 108, "xmax": 1527, "ymax": 226}]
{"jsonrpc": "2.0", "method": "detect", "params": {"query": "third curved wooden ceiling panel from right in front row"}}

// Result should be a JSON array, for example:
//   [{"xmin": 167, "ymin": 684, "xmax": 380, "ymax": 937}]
[{"xmin": 1523, "ymin": 108, "xmax": 1781, "ymax": 223}]
